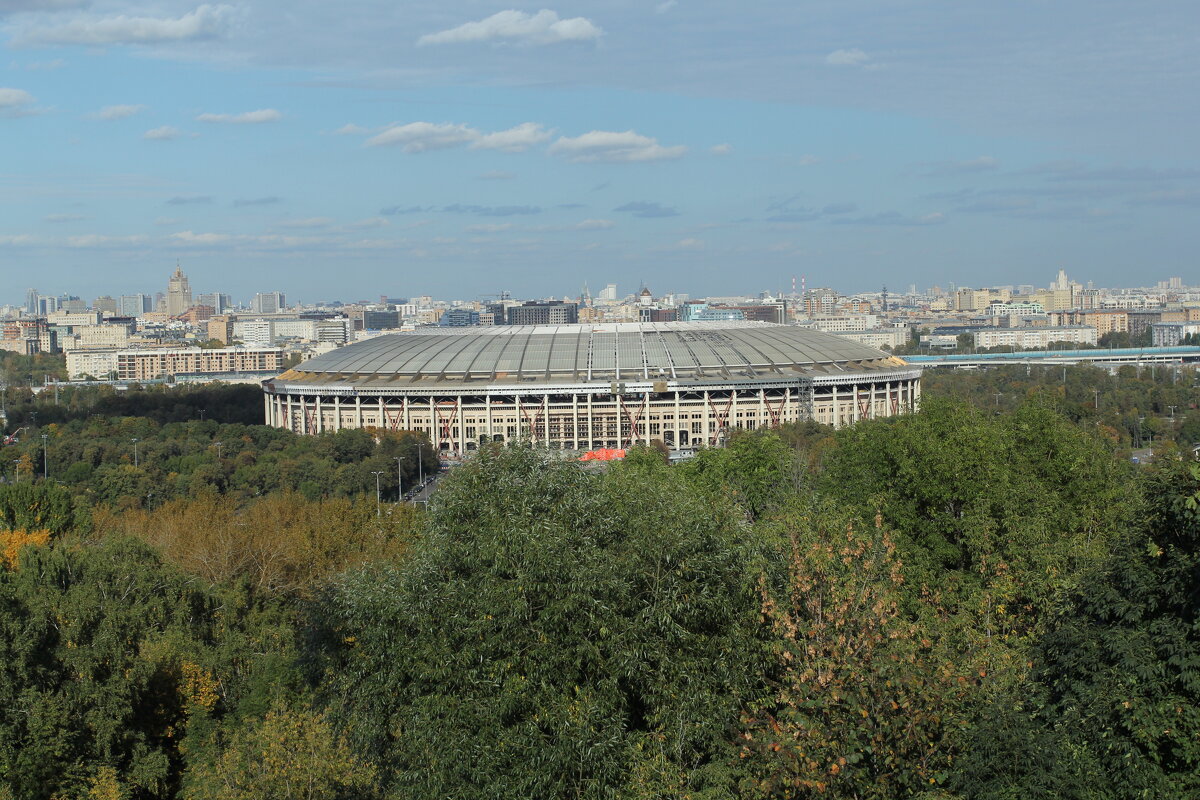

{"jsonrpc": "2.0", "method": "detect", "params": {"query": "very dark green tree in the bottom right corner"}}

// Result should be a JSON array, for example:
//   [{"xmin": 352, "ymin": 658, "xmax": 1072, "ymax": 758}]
[{"xmin": 956, "ymin": 463, "xmax": 1200, "ymax": 800}]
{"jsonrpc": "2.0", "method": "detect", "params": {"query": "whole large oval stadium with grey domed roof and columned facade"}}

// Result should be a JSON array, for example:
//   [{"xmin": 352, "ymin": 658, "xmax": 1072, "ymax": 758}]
[{"xmin": 263, "ymin": 321, "xmax": 920, "ymax": 455}]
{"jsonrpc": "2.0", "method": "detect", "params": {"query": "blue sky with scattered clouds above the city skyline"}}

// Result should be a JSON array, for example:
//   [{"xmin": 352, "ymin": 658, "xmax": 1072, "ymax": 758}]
[{"xmin": 0, "ymin": 0, "xmax": 1200, "ymax": 302}]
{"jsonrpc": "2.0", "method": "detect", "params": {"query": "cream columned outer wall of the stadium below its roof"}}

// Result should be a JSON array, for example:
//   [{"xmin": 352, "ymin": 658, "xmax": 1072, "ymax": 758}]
[{"xmin": 264, "ymin": 368, "xmax": 920, "ymax": 455}]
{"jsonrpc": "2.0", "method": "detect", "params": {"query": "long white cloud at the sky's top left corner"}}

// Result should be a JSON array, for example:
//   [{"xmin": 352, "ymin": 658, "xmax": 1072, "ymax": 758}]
[{"xmin": 24, "ymin": 5, "xmax": 233, "ymax": 44}]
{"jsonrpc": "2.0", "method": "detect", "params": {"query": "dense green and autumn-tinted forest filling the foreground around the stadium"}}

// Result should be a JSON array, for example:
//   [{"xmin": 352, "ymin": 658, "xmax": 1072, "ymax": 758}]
[{"xmin": 0, "ymin": 352, "xmax": 1200, "ymax": 800}]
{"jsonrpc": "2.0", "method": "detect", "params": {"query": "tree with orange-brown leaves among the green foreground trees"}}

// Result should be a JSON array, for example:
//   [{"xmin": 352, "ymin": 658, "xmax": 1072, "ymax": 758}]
[{"xmin": 742, "ymin": 506, "xmax": 974, "ymax": 800}]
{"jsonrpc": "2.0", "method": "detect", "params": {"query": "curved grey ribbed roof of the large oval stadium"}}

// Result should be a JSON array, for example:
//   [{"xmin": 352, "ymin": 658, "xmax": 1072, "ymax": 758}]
[{"xmin": 280, "ymin": 323, "xmax": 904, "ymax": 386}]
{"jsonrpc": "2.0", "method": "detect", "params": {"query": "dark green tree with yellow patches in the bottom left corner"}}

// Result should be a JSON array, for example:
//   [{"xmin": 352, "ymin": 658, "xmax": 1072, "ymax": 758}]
[{"xmin": 0, "ymin": 539, "xmax": 304, "ymax": 800}]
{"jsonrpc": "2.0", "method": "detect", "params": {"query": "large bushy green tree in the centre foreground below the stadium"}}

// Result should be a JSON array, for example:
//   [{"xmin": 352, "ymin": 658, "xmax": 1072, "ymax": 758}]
[{"xmin": 313, "ymin": 447, "xmax": 762, "ymax": 799}]
